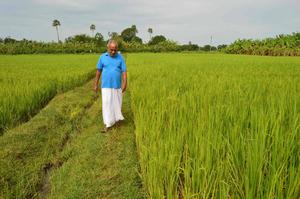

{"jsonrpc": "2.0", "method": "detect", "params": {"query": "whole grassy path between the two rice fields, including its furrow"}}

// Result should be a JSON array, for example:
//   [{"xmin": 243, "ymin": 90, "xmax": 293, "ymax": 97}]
[{"xmin": 0, "ymin": 82, "xmax": 143, "ymax": 198}]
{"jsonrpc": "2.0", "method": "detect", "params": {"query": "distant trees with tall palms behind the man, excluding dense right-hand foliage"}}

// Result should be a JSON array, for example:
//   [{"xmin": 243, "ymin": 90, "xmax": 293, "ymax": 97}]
[{"xmin": 0, "ymin": 19, "xmax": 223, "ymax": 54}]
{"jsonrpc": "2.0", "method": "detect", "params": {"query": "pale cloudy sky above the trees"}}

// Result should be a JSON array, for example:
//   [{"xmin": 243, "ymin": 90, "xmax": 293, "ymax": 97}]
[{"xmin": 0, "ymin": 0, "xmax": 300, "ymax": 45}]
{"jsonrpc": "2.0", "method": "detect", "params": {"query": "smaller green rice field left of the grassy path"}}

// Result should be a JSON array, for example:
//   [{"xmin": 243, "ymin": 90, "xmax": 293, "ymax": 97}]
[{"xmin": 0, "ymin": 55, "xmax": 96, "ymax": 133}]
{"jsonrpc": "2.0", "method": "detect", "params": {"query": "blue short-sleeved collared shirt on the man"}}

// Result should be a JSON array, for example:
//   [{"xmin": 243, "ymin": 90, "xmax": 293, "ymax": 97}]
[{"xmin": 97, "ymin": 52, "xmax": 126, "ymax": 88}]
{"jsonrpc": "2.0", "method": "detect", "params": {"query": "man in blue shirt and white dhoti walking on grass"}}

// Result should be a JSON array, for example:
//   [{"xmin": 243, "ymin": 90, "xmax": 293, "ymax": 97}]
[{"xmin": 94, "ymin": 40, "xmax": 127, "ymax": 133}]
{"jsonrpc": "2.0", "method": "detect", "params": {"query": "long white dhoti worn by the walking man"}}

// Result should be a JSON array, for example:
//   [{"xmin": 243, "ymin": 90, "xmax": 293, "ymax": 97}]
[{"xmin": 101, "ymin": 88, "xmax": 124, "ymax": 127}]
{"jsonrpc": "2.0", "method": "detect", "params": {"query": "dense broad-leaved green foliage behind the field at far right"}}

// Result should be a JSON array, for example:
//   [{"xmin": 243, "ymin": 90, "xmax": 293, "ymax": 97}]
[{"xmin": 223, "ymin": 33, "xmax": 300, "ymax": 56}]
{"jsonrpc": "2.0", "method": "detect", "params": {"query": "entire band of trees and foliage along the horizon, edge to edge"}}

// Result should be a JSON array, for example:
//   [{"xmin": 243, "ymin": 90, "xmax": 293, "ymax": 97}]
[{"xmin": 0, "ymin": 19, "xmax": 300, "ymax": 56}]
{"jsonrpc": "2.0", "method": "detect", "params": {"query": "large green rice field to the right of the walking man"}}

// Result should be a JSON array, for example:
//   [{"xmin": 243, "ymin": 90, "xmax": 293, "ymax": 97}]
[{"xmin": 128, "ymin": 54, "xmax": 300, "ymax": 198}]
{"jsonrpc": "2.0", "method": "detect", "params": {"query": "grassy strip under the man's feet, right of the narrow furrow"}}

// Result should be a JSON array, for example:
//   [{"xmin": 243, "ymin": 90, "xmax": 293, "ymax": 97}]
[{"xmin": 49, "ymin": 91, "xmax": 144, "ymax": 198}]
